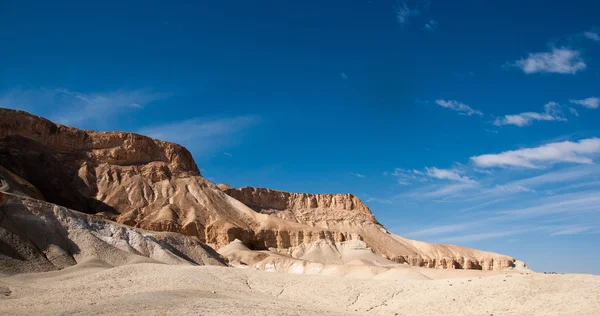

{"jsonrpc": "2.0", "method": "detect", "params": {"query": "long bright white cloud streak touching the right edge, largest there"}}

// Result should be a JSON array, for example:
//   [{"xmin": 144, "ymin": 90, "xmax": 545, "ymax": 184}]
[{"xmin": 471, "ymin": 138, "xmax": 600, "ymax": 168}]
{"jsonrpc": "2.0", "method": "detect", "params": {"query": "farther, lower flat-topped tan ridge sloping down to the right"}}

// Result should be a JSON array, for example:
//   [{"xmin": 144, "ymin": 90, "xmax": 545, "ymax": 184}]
[{"xmin": 225, "ymin": 187, "xmax": 516, "ymax": 270}]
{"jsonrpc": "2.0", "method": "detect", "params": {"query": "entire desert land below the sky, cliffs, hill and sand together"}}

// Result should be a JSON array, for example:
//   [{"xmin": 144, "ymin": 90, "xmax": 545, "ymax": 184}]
[{"xmin": 0, "ymin": 109, "xmax": 600, "ymax": 315}]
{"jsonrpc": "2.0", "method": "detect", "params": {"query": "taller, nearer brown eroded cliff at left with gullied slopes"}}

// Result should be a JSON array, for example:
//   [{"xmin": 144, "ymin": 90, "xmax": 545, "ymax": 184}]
[{"xmin": 0, "ymin": 109, "xmax": 349, "ymax": 249}]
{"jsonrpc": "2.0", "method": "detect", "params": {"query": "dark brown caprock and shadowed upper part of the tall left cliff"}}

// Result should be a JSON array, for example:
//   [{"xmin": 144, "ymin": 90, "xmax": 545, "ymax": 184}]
[{"xmin": 0, "ymin": 109, "xmax": 200, "ymax": 214}]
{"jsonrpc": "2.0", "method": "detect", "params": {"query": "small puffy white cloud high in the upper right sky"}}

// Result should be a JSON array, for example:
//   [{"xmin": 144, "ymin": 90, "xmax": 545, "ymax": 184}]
[{"xmin": 514, "ymin": 47, "xmax": 587, "ymax": 74}]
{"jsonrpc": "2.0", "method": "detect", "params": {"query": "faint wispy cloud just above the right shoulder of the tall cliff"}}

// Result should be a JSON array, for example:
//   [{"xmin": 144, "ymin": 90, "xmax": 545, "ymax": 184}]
[{"xmin": 138, "ymin": 115, "xmax": 259, "ymax": 156}]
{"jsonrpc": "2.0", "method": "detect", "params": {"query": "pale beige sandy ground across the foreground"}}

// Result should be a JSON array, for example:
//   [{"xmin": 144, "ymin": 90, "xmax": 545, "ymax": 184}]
[{"xmin": 0, "ymin": 261, "xmax": 600, "ymax": 316}]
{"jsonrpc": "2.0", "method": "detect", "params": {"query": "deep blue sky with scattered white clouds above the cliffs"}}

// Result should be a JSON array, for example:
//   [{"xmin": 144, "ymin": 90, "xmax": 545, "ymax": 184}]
[{"xmin": 0, "ymin": 0, "xmax": 600, "ymax": 273}]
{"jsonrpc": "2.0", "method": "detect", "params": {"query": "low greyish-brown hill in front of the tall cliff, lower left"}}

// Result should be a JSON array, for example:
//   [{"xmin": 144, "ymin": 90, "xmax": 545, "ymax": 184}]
[{"xmin": 0, "ymin": 192, "xmax": 226, "ymax": 274}]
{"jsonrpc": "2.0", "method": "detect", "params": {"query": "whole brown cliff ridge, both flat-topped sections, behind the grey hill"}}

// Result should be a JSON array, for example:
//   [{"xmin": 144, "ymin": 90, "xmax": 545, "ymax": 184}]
[{"xmin": 0, "ymin": 109, "xmax": 514, "ymax": 270}]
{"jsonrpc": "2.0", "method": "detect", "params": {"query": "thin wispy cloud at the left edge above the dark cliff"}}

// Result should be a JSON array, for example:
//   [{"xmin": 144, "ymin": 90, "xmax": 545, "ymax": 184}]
[{"xmin": 0, "ymin": 88, "xmax": 171, "ymax": 125}]
